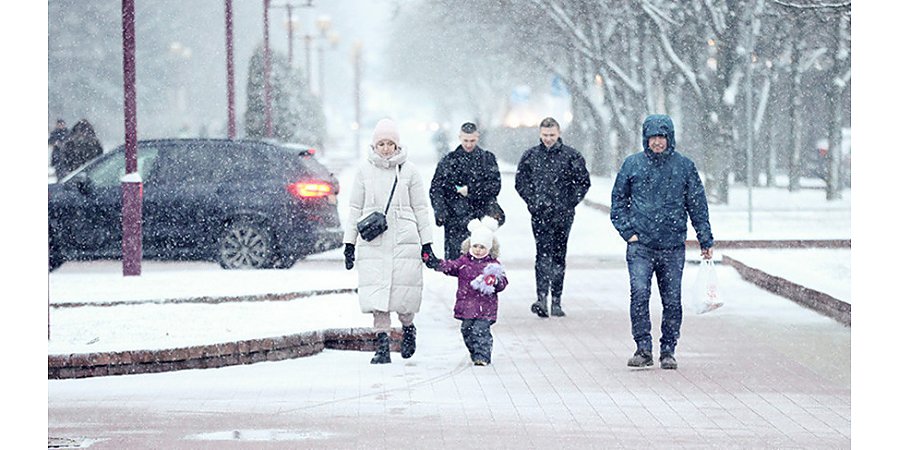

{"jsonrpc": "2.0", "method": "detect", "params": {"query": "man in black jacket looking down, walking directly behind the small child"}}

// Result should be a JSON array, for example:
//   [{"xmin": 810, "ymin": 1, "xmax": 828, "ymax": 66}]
[{"xmin": 429, "ymin": 122, "xmax": 502, "ymax": 259}]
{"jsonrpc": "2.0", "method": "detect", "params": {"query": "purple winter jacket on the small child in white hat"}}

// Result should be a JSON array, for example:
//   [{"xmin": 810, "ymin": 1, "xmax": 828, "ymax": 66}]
[{"xmin": 438, "ymin": 253, "xmax": 508, "ymax": 321}]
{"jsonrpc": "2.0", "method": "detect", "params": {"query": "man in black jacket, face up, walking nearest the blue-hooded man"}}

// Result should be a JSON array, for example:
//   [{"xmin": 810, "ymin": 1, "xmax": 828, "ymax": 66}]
[{"xmin": 516, "ymin": 117, "xmax": 591, "ymax": 317}]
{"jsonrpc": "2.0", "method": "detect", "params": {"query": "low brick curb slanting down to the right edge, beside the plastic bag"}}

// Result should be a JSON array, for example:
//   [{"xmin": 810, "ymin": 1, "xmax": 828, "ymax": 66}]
[{"xmin": 722, "ymin": 255, "xmax": 850, "ymax": 327}]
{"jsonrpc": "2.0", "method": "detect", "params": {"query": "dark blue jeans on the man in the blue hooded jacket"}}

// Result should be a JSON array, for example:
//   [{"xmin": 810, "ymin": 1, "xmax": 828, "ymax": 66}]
[{"xmin": 625, "ymin": 242, "xmax": 684, "ymax": 353}]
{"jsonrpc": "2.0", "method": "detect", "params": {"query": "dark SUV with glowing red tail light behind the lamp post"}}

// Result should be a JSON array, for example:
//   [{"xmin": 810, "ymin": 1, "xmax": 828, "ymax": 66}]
[{"xmin": 48, "ymin": 139, "xmax": 342, "ymax": 270}]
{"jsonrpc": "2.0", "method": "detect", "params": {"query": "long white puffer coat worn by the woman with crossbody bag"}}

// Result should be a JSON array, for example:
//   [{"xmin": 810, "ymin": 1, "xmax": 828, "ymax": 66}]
[{"xmin": 344, "ymin": 147, "xmax": 431, "ymax": 314}]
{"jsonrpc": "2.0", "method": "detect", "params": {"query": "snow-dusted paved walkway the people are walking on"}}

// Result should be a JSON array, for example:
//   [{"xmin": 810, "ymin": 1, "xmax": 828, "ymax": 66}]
[{"xmin": 48, "ymin": 263, "xmax": 851, "ymax": 449}]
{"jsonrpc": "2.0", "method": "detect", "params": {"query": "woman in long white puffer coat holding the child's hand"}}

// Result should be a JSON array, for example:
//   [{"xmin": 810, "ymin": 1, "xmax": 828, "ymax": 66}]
[{"xmin": 344, "ymin": 119, "xmax": 438, "ymax": 364}]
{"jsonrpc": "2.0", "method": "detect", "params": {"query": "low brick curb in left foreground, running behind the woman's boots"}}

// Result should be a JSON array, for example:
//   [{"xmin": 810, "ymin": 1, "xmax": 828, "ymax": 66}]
[{"xmin": 47, "ymin": 328, "xmax": 403, "ymax": 380}]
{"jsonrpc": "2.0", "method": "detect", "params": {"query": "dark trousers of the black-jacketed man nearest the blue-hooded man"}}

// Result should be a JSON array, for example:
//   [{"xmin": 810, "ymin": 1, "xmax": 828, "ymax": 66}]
[{"xmin": 531, "ymin": 211, "xmax": 575, "ymax": 297}]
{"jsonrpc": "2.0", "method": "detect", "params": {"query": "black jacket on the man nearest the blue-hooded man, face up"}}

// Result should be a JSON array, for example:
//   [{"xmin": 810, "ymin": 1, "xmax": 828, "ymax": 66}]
[{"xmin": 516, "ymin": 138, "xmax": 591, "ymax": 216}]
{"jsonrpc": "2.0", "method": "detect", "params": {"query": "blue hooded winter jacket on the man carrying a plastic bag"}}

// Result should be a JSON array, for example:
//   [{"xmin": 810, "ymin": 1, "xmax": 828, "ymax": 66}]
[{"xmin": 610, "ymin": 115, "xmax": 713, "ymax": 249}]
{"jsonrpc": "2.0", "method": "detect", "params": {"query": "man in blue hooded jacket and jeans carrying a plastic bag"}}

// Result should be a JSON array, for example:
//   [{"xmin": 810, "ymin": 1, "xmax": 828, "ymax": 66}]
[{"xmin": 610, "ymin": 114, "xmax": 713, "ymax": 369}]
